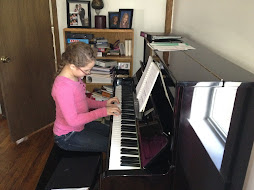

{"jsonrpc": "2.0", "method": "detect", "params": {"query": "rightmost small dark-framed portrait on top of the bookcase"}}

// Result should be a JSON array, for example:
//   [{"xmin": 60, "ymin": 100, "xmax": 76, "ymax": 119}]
[{"xmin": 119, "ymin": 9, "xmax": 133, "ymax": 28}]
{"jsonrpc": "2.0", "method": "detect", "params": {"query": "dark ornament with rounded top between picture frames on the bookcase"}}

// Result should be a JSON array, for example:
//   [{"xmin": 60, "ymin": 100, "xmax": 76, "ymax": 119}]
[{"xmin": 92, "ymin": 0, "xmax": 106, "ymax": 29}]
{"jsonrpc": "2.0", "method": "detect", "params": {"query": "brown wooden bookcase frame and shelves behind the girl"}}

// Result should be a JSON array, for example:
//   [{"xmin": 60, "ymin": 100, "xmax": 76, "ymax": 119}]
[{"xmin": 63, "ymin": 28, "xmax": 134, "ymax": 91}]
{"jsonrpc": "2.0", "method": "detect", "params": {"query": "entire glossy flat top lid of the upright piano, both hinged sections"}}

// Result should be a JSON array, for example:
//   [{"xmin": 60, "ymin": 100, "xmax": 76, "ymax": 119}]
[{"xmin": 155, "ymin": 38, "xmax": 254, "ymax": 84}]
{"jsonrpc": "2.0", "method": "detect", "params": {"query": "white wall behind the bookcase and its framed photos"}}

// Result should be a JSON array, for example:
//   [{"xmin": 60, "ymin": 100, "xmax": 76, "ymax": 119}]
[{"xmin": 56, "ymin": 0, "xmax": 166, "ymax": 73}]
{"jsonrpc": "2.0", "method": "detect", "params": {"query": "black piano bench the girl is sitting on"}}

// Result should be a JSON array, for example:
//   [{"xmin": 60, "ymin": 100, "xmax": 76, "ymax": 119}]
[{"xmin": 36, "ymin": 144, "xmax": 102, "ymax": 190}]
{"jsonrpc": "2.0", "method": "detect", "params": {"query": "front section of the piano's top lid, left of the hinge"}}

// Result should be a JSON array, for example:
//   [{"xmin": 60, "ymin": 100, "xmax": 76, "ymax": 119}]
[{"xmin": 155, "ymin": 51, "xmax": 221, "ymax": 86}]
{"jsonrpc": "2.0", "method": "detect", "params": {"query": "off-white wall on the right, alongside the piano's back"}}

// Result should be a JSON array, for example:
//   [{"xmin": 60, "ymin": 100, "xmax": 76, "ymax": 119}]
[{"xmin": 172, "ymin": 0, "xmax": 254, "ymax": 190}]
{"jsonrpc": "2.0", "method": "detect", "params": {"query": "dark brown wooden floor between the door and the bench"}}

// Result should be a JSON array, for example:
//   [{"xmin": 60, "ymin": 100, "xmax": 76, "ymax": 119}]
[{"xmin": 0, "ymin": 116, "xmax": 54, "ymax": 190}]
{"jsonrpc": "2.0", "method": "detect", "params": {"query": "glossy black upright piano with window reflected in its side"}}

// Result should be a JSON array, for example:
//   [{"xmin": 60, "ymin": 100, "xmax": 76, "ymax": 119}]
[{"xmin": 101, "ymin": 36, "xmax": 254, "ymax": 190}]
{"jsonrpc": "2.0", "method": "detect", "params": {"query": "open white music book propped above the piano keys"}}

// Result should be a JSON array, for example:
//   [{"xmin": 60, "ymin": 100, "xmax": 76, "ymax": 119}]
[{"xmin": 136, "ymin": 56, "xmax": 160, "ymax": 112}]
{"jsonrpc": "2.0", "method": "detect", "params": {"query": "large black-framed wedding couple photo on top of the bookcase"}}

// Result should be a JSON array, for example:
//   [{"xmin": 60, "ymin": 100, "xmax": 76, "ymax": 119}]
[{"xmin": 66, "ymin": 0, "xmax": 91, "ymax": 28}]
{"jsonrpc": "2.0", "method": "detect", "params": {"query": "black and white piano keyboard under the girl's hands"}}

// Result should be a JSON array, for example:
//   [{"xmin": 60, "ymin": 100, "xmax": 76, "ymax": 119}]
[{"xmin": 109, "ymin": 85, "xmax": 140, "ymax": 170}]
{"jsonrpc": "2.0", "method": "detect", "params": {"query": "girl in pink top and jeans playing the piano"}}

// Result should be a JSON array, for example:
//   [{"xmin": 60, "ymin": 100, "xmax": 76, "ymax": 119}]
[{"xmin": 52, "ymin": 42, "xmax": 120, "ymax": 152}]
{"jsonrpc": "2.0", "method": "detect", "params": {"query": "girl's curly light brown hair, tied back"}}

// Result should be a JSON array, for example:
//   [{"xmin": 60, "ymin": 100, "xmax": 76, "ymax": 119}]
[{"xmin": 56, "ymin": 42, "xmax": 97, "ymax": 76}]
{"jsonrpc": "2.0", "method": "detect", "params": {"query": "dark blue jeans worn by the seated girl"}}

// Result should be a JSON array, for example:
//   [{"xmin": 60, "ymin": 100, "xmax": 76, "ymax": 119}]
[{"xmin": 55, "ymin": 121, "xmax": 109, "ymax": 152}]
